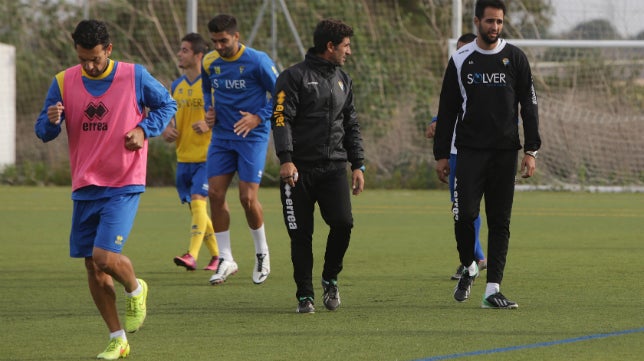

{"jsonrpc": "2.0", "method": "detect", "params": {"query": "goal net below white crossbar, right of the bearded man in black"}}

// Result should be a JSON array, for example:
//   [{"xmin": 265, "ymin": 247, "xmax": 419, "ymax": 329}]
[{"xmin": 510, "ymin": 40, "xmax": 644, "ymax": 187}]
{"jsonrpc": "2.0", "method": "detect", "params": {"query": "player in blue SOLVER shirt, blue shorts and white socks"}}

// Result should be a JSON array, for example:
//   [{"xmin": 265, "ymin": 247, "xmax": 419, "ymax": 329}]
[{"xmin": 202, "ymin": 14, "xmax": 277, "ymax": 285}]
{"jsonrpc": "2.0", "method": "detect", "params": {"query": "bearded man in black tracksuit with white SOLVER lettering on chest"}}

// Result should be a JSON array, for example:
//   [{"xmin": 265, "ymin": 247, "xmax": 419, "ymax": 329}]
[{"xmin": 434, "ymin": 0, "xmax": 541, "ymax": 308}]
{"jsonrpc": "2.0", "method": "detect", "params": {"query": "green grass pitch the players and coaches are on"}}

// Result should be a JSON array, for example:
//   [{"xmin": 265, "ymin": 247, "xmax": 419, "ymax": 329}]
[{"xmin": 0, "ymin": 187, "xmax": 644, "ymax": 361}]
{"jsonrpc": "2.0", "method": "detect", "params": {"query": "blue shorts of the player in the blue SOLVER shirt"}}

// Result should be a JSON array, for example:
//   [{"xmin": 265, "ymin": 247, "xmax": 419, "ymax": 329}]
[{"xmin": 207, "ymin": 139, "xmax": 268, "ymax": 183}]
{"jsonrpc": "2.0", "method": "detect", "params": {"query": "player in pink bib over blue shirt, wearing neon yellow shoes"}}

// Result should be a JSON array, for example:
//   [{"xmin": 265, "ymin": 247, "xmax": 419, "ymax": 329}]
[{"xmin": 35, "ymin": 20, "xmax": 177, "ymax": 360}]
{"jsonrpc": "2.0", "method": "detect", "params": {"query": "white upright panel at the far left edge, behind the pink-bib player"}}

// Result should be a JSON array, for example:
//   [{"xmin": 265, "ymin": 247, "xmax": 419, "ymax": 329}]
[{"xmin": 0, "ymin": 43, "xmax": 16, "ymax": 171}]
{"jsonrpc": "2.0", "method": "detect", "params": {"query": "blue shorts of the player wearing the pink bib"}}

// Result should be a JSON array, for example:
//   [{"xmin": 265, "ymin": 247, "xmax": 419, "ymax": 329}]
[{"xmin": 69, "ymin": 193, "xmax": 141, "ymax": 258}]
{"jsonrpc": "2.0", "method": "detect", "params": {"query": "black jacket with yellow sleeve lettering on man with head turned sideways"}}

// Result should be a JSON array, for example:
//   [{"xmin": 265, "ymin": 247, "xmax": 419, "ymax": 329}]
[{"xmin": 271, "ymin": 50, "xmax": 364, "ymax": 170}]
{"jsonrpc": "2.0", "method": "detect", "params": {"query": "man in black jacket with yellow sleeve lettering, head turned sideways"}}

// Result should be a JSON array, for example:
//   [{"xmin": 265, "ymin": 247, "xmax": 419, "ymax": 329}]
[{"xmin": 271, "ymin": 19, "xmax": 364, "ymax": 313}]
